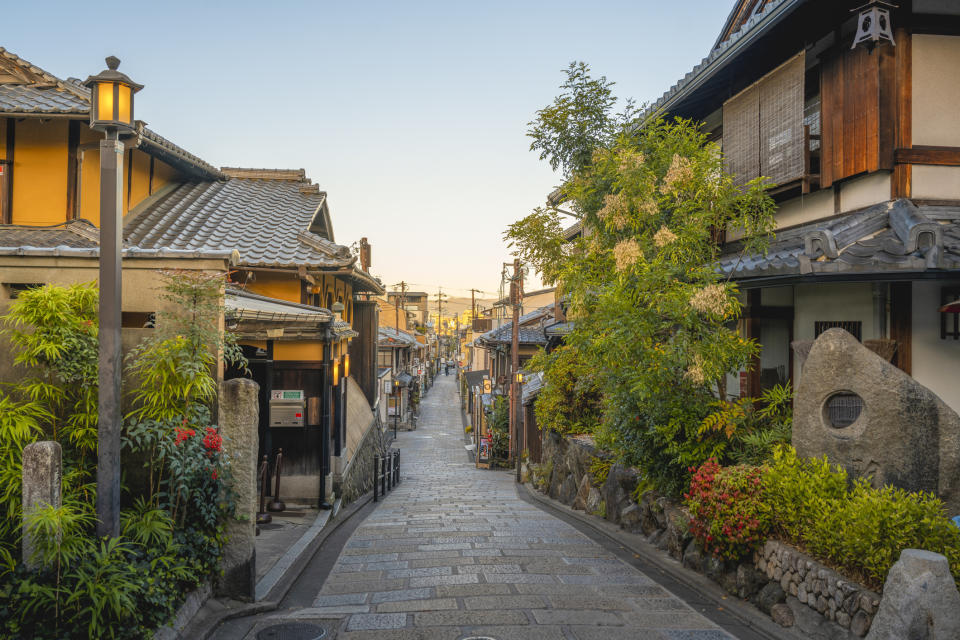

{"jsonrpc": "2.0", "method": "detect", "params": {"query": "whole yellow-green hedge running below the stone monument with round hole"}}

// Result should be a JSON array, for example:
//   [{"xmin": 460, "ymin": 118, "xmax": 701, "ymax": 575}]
[{"xmin": 764, "ymin": 447, "xmax": 960, "ymax": 588}]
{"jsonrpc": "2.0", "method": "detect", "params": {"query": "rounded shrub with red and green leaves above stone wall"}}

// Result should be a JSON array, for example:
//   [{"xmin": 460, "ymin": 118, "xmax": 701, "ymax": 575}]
[{"xmin": 683, "ymin": 458, "xmax": 770, "ymax": 560}]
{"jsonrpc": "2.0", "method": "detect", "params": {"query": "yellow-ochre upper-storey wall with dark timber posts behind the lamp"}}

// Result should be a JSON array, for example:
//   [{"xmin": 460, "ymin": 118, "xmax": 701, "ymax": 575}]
[{"xmin": 0, "ymin": 118, "xmax": 180, "ymax": 226}]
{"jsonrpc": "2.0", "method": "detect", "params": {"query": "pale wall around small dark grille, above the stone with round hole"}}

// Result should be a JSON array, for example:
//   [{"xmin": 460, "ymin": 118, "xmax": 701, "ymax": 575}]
[{"xmin": 793, "ymin": 282, "xmax": 877, "ymax": 382}]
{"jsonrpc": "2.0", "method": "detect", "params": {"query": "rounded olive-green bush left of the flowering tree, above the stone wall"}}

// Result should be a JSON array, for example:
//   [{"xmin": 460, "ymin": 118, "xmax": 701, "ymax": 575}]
[{"xmin": 528, "ymin": 346, "xmax": 602, "ymax": 434}]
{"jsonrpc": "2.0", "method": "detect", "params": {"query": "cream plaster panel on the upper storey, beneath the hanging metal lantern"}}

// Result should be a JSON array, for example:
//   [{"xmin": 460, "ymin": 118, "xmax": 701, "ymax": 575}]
[{"xmin": 913, "ymin": 36, "xmax": 960, "ymax": 147}]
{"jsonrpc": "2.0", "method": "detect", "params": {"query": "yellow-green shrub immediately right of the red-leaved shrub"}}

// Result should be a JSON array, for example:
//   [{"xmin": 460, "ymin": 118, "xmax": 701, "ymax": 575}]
[{"xmin": 763, "ymin": 446, "xmax": 847, "ymax": 543}]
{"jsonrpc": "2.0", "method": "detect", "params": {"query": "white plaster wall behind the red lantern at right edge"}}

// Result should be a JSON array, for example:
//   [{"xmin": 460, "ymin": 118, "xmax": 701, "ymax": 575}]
[{"xmin": 911, "ymin": 281, "xmax": 960, "ymax": 412}]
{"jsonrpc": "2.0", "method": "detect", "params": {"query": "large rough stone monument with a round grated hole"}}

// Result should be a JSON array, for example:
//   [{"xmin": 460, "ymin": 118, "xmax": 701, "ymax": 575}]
[{"xmin": 793, "ymin": 329, "xmax": 960, "ymax": 515}]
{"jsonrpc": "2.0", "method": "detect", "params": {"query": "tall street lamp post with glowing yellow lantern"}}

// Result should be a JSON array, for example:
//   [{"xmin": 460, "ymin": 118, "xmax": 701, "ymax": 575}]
[{"xmin": 84, "ymin": 56, "xmax": 143, "ymax": 538}]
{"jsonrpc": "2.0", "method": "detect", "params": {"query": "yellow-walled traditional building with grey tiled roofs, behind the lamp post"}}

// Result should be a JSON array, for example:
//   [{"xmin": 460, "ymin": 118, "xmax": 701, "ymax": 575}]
[{"xmin": 0, "ymin": 48, "xmax": 383, "ymax": 502}]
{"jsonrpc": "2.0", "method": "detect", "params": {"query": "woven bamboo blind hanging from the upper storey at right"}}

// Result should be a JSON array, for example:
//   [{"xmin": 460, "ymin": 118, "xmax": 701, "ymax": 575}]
[{"xmin": 723, "ymin": 53, "xmax": 806, "ymax": 185}]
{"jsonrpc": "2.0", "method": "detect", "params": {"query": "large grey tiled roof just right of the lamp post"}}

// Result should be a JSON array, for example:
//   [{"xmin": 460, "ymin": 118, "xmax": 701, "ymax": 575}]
[{"xmin": 125, "ymin": 178, "xmax": 354, "ymax": 268}]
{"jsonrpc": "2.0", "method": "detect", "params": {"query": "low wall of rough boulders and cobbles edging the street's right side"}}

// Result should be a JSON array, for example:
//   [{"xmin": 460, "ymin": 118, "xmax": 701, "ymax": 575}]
[{"xmin": 533, "ymin": 433, "xmax": 880, "ymax": 640}]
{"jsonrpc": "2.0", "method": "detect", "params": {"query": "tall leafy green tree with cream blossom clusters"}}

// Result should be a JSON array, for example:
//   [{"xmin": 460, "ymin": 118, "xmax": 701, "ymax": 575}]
[{"xmin": 505, "ymin": 64, "xmax": 774, "ymax": 495}]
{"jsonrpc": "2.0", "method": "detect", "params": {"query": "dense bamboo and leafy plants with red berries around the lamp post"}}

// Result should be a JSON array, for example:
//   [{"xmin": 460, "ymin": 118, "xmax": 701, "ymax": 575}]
[{"xmin": 0, "ymin": 272, "xmax": 243, "ymax": 640}]
